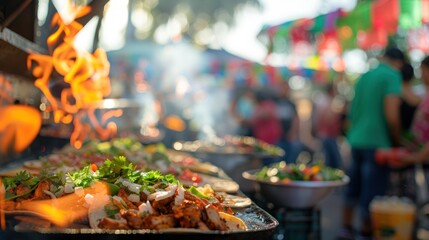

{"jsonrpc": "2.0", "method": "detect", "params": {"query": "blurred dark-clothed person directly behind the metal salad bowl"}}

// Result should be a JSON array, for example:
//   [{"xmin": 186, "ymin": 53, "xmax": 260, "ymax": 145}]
[{"xmin": 276, "ymin": 81, "xmax": 306, "ymax": 163}]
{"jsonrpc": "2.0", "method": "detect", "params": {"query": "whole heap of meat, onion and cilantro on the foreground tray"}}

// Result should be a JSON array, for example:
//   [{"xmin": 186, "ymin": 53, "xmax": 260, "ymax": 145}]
[{"xmin": 3, "ymin": 157, "xmax": 246, "ymax": 231}]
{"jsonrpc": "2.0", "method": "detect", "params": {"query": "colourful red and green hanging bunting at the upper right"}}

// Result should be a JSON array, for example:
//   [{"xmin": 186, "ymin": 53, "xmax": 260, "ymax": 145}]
[{"xmin": 259, "ymin": 0, "xmax": 429, "ymax": 70}]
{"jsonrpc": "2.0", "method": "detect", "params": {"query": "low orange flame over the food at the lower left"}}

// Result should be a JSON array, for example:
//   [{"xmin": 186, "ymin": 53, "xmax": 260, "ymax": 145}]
[{"xmin": 22, "ymin": 182, "xmax": 109, "ymax": 227}]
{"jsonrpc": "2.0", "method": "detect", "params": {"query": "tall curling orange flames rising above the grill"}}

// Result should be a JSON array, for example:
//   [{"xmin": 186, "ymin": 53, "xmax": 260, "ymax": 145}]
[{"xmin": 27, "ymin": 6, "xmax": 122, "ymax": 148}]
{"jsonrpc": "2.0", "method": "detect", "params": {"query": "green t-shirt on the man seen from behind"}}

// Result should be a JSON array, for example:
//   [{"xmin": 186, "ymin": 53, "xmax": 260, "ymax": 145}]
[{"xmin": 348, "ymin": 63, "xmax": 402, "ymax": 148}]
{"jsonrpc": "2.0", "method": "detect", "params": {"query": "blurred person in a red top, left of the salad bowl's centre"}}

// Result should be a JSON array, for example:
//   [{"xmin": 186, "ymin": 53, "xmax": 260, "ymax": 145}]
[{"xmin": 252, "ymin": 92, "xmax": 282, "ymax": 144}]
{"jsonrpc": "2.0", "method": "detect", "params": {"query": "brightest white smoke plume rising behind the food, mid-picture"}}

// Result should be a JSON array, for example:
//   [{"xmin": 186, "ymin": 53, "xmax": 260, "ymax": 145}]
[{"xmin": 151, "ymin": 43, "xmax": 237, "ymax": 140}]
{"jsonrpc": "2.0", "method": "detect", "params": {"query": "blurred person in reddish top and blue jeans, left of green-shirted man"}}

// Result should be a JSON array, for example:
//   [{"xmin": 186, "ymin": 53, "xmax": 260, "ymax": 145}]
[{"xmin": 312, "ymin": 83, "xmax": 342, "ymax": 168}]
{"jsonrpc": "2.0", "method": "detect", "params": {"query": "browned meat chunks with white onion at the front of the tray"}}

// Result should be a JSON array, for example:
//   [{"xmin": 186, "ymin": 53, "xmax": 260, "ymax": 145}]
[{"xmin": 88, "ymin": 184, "xmax": 247, "ymax": 231}]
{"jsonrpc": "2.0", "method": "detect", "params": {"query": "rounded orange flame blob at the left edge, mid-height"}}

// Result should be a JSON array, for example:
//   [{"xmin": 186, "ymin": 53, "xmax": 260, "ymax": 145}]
[{"xmin": 0, "ymin": 105, "xmax": 42, "ymax": 153}]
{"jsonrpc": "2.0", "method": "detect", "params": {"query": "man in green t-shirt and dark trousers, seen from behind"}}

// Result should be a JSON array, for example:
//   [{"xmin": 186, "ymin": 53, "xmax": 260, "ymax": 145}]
[{"xmin": 339, "ymin": 48, "xmax": 405, "ymax": 239}]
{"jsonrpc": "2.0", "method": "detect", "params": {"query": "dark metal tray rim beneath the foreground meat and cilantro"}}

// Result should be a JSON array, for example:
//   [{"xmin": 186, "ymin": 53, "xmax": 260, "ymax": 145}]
[{"xmin": 0, "ymin": 203, "xmax": 279, "ymax": 240}]
